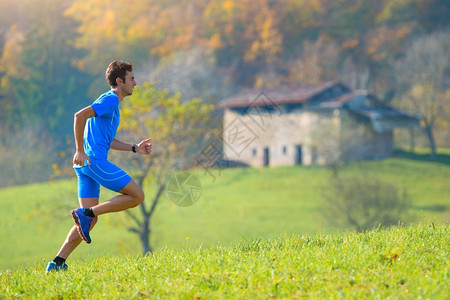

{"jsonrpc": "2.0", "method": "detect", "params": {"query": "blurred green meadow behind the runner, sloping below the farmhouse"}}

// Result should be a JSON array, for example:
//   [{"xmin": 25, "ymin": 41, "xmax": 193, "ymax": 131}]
[{"xmin": 0, "ymin": 151, "xmax": 450, "ymax": 270}]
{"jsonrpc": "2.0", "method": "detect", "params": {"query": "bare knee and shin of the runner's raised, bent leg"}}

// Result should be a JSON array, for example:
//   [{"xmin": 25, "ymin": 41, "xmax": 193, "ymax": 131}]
[{"xmin": 91, "ymin": 180, "xmax": 144, "ymax": 216}]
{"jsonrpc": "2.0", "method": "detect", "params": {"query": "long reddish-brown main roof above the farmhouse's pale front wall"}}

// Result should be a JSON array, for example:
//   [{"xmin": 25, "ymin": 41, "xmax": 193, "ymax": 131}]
[{"xmin": 219, "ymin": 81, "xmax": 344, "ymax": 108}]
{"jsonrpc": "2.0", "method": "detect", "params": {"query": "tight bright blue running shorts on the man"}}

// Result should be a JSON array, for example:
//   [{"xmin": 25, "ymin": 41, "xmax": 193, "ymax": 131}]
[{"xmin": 74, "ymin": 160, "xmax": 131, "ymax": 198}]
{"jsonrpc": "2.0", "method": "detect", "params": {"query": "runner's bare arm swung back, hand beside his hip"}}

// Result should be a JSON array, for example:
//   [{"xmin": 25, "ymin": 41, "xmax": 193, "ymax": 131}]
[{"xmin": 73, "ymin": 106, "xmax": 95, "ymax": 166}]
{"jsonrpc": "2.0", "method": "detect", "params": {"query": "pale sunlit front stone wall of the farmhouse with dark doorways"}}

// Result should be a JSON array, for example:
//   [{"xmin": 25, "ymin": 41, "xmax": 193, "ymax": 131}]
[{"xmin": 223, "ymin": 109, "xmax": 340, "ymax": 167}]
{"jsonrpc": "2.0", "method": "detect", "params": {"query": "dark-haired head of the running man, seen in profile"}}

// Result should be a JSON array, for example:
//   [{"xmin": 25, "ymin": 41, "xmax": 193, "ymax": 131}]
[{"xmin": 105, "ymin": 60, "xmax": 136, "ymax": 96}]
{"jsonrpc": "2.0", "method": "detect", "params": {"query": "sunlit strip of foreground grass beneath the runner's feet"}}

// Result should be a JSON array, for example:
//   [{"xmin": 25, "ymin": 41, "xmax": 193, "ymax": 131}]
[{"xmin": 0, "ymin": 224, "xmax": 450, "ymax": 299}]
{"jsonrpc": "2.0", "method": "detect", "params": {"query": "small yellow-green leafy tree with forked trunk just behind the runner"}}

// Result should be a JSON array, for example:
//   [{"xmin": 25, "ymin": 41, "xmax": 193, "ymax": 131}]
[{"xmin": 110, "ymin": 83, "xmax": 213, "ymax": 253}]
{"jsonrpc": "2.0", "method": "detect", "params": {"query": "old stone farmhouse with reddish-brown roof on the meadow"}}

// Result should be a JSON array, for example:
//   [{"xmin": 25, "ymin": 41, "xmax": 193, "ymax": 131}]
[{"xmin": 219, "ymin": 81, "xmax": 419, "ymax": 167}]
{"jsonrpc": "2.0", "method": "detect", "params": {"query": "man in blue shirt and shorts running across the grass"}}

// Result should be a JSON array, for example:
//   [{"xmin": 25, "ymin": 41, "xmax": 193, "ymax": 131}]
[{"xmin": 45, "ymin": 61, "xmax": 152, "ymax": 274}]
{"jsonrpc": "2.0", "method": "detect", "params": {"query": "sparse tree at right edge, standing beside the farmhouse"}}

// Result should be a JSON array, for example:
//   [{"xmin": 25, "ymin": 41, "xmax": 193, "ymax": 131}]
[{"xmin": 395, "ymin": 31, "xmax": 450, "ymax": 158}]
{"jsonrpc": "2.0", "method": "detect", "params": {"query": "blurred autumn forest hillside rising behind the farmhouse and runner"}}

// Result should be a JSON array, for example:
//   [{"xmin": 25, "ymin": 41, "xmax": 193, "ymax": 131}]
[{"xmin": 0, "ymin": 0, "xmax": 450, "ymax": 186}]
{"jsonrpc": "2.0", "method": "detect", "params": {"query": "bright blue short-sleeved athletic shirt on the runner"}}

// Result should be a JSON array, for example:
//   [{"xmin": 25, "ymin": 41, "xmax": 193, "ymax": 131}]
[{"xmin": 84, "ymin": 90, "xmax": 120, "ymax": 164}]
